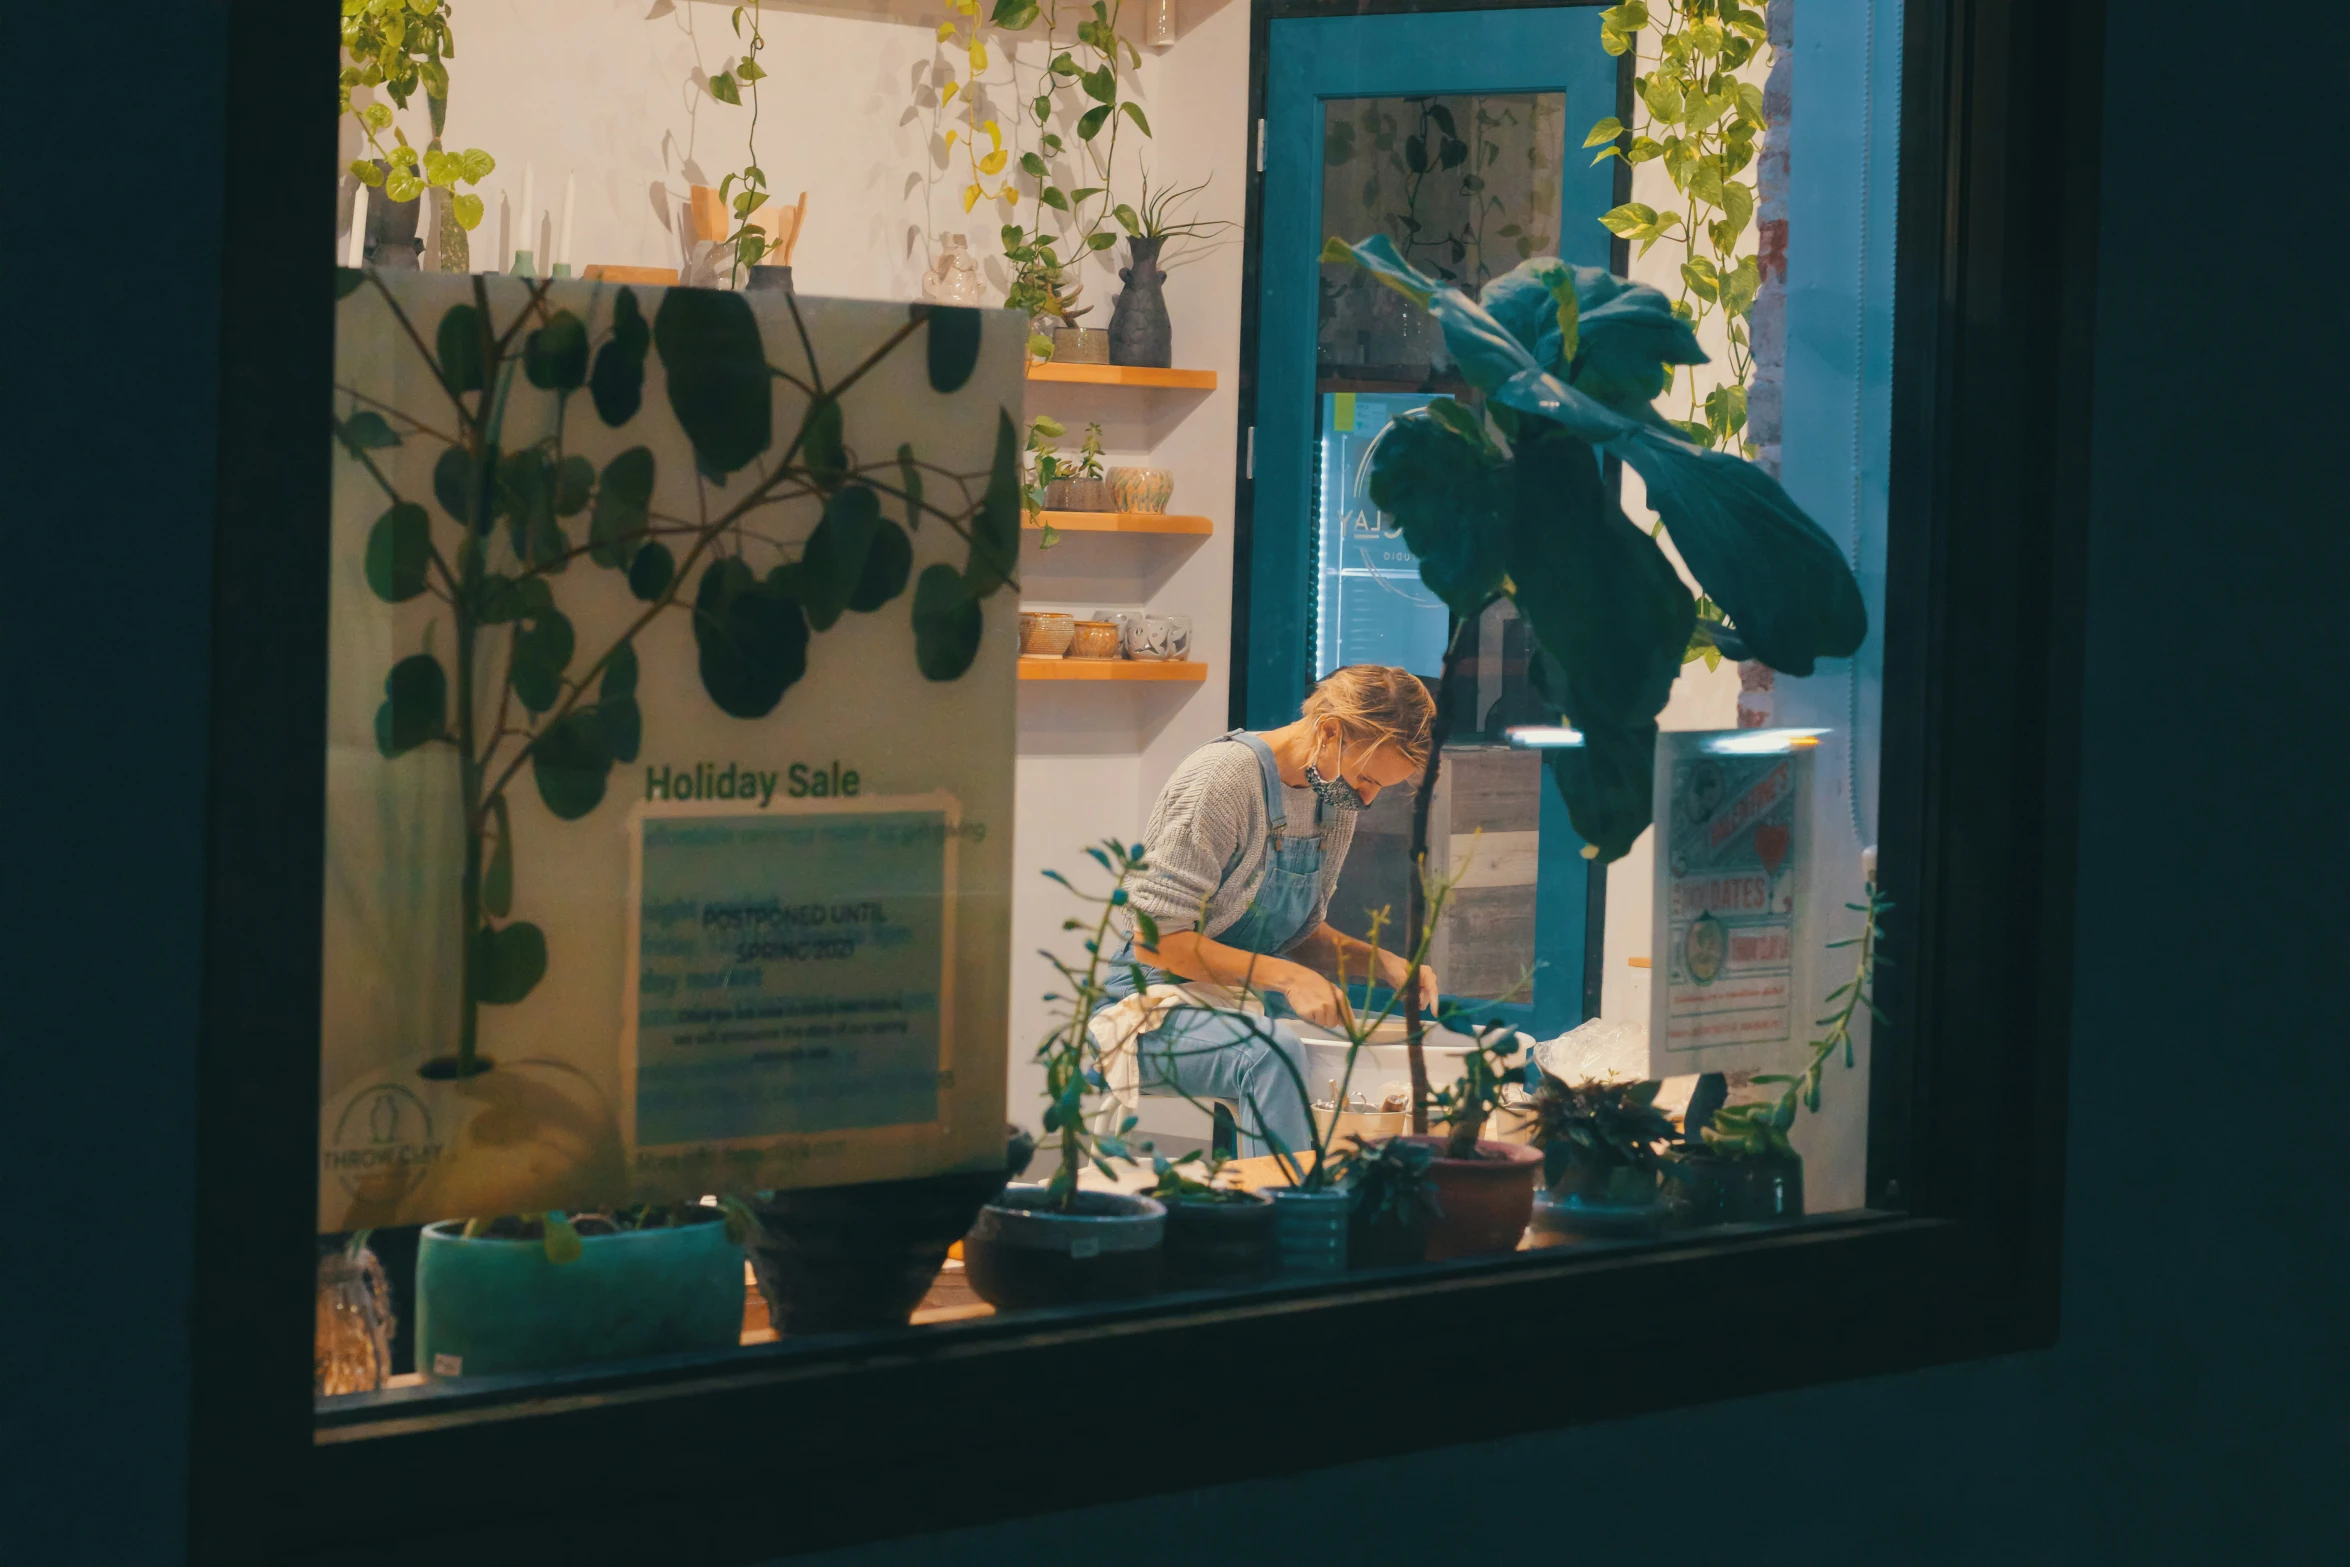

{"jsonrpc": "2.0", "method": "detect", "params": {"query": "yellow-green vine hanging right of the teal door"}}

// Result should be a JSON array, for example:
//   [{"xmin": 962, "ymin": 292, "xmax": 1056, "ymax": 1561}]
[{"xmin": 1584, "ymin": 0, "xmax": 1767, "ymax": 456}]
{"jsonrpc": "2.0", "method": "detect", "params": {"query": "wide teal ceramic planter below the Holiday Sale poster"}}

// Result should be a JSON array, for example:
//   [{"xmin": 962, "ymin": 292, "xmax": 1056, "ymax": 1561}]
[{"xmin": 416, "ymin": 1222, "xmax": 743, "ymax": 1377}]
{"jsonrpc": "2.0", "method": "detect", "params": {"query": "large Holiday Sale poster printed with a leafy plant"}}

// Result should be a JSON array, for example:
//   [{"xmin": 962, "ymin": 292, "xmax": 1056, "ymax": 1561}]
[{"xmin": 317, "ymin": 273, "xmax": 1027, "ymax": 1231}]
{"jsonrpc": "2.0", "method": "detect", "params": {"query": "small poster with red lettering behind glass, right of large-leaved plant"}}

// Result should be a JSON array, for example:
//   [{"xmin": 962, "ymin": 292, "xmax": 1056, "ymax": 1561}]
[{"xmin": 1650, "ymin": 731, "xmax": 1812, "ymax": 1076}]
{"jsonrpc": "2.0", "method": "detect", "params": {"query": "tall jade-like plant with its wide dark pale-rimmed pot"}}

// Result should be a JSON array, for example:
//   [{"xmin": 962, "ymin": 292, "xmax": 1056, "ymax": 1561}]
[{"xmin": 964, "ymin": 839, "xmax": 1168, "ymax": 1311}]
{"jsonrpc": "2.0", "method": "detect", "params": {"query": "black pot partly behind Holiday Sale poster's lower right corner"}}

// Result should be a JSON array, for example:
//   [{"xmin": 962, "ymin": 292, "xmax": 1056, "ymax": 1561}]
[{"xmin": 750, "ymin": 1132, "xmax": 1034, "ymax": 1334}]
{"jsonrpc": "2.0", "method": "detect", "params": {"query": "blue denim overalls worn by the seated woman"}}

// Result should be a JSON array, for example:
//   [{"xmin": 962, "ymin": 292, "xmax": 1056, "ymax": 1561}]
[{"xmin": 1097, "ymin": 728, "xmax": 1323, "ymax": 1154}]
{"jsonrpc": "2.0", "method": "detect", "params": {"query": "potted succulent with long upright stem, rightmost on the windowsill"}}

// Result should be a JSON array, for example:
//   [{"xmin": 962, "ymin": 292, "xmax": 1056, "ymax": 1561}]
[{"xmin": 1673, "ymin": 883, "xmax": 1894, "ymax": 1224}]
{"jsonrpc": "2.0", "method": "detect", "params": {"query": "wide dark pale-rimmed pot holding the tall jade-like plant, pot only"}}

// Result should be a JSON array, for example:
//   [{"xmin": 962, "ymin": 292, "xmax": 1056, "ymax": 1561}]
[{"xmin": 964, "ymin": 1186, "xmax": 1168, "ymax": 1311}]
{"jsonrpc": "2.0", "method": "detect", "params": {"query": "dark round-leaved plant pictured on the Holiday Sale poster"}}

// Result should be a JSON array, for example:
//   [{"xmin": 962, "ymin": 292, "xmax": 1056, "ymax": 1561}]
[{"xmin": 336, "ymin": 273, "xmax": 1020, "ymax": 1076}]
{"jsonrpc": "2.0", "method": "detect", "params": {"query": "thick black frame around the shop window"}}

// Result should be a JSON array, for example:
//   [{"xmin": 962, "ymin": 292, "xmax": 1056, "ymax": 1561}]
[{"xmin": 188, "ymin": 0, "xmax": 2103, "ymax": 1565}]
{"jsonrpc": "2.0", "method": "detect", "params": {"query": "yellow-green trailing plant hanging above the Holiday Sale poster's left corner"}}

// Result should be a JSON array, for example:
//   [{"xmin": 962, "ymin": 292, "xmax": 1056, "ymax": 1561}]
[{"xmin": 338, "ymin": 0, "xmax": 498, "ymax": 230}]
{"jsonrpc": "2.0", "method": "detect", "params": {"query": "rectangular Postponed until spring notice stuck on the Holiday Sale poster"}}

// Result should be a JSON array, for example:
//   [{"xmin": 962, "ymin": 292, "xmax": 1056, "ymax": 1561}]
[{"xmin": 620, "ymin": 794, "xmax": 961, "ymax": 1189}]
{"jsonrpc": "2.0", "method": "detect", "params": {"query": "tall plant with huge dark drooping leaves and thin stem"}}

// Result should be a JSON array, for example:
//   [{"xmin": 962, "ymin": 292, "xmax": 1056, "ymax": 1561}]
[{"xmin": 1323, "ymin": 235, "xmax": 1868, "ymax": 1125}]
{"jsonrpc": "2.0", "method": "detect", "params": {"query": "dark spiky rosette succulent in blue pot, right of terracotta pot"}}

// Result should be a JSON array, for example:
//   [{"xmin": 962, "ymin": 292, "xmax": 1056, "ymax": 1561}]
[{"xmin": 1528, "ymin": 1071, "xmax": 1678, "ymax": 1240}]
